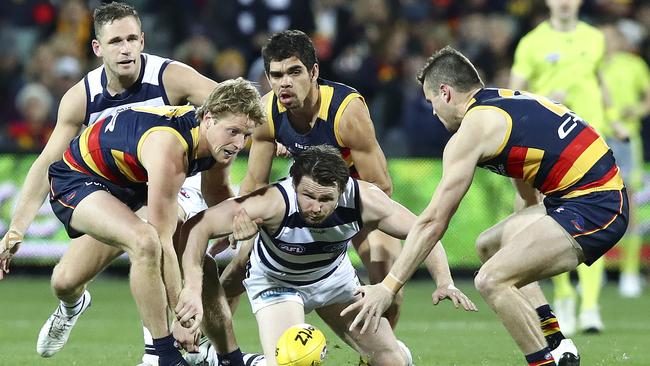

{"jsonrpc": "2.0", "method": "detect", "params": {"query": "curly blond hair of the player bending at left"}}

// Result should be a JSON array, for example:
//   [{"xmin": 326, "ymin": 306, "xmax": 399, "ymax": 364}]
[{"xmin": 196, "ymin": 78, "xmax": 265, "ymax": 125}]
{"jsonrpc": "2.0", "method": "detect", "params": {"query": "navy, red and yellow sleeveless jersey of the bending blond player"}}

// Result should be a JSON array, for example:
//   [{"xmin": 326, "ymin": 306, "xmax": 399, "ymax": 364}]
[{"xmin": 63, "ymin": 106, "xmax": 214, "ymax": 187}]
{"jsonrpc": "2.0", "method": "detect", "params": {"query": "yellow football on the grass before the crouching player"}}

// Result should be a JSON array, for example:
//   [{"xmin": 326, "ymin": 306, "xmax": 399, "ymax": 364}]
[{"xmin": 275, "ymin": 324, "xmax": 327, "ymax": 366}]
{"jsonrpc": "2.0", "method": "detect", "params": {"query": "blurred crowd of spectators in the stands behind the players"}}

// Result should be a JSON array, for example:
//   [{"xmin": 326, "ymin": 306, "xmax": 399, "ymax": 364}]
[{"xmin": 0, "ymin": 0, "xmax": 650, "ymax": 156}]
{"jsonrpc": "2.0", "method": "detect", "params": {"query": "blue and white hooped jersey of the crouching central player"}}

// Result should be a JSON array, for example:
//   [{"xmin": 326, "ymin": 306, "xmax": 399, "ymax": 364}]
[{"xmin": 251, "ymin": 178, "xmax": 362, "ymax": 286}]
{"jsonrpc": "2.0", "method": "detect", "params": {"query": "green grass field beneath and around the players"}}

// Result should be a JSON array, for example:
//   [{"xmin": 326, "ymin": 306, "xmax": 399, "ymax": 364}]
[{"xmin": 0, "ymin": 277, "xmax": 650, "ymax": 366}]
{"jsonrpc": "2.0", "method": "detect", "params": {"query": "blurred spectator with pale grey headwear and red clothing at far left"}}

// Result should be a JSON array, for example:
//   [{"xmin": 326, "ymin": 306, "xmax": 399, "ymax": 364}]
[{"xmin": 8, "ymin": 83, "xmax": 54, "ymax": 151}]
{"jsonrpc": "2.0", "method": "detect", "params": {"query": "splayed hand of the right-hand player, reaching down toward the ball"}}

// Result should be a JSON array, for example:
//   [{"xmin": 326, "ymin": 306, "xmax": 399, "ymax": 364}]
[{"xmin": 341, "ymin": 283, "xmax": 395, "ymax": 334}]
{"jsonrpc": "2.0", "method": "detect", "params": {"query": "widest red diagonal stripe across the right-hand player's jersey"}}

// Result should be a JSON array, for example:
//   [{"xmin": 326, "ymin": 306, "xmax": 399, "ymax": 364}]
[{"xmin": 540, "ymin": 127, "xmax": 598, "ymax": 193}]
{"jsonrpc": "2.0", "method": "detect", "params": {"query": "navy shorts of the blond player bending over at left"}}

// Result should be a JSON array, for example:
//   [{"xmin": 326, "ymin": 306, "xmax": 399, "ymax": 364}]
[{"xmin": 48, "ymin": 160, "xmax": 147, "ymax": 239}]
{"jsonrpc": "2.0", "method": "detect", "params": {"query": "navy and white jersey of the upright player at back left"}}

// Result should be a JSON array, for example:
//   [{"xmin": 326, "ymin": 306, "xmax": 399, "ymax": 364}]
[{"xmin": 84, "ymin": 53, "xmax": 172, "ymax": 126}]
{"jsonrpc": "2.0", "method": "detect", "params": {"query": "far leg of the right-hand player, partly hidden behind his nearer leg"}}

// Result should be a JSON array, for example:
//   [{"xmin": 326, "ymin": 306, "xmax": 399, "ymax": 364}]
[{"xmin": 476, "ymin": 204, "xmax": 568, "ymax": 349}]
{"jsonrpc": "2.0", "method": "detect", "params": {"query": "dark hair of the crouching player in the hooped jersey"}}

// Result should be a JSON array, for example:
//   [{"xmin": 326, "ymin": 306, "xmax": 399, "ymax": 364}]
[{"xmin": 289, "ymin": 145, "xmax": 350, "ymax": 192}]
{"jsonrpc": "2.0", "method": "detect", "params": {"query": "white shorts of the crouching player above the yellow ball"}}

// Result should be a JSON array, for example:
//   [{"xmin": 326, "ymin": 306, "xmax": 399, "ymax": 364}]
[{"xmin": 244, "ymin": 255, "xmax": 361, "ymax": 314}]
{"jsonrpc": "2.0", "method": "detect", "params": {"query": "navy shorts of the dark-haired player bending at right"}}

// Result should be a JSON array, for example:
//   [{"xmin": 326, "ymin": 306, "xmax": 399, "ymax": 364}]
[{"xmin": 544, "ymin": 189, "xmax": 629, "ymax": 265}]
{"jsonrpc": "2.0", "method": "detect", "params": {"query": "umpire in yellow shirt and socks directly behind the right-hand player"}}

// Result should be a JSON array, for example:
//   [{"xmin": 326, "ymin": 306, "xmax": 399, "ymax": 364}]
[{"xmin": 510, "ymin": 0, "xmax": 609, "ymax": 336}]
